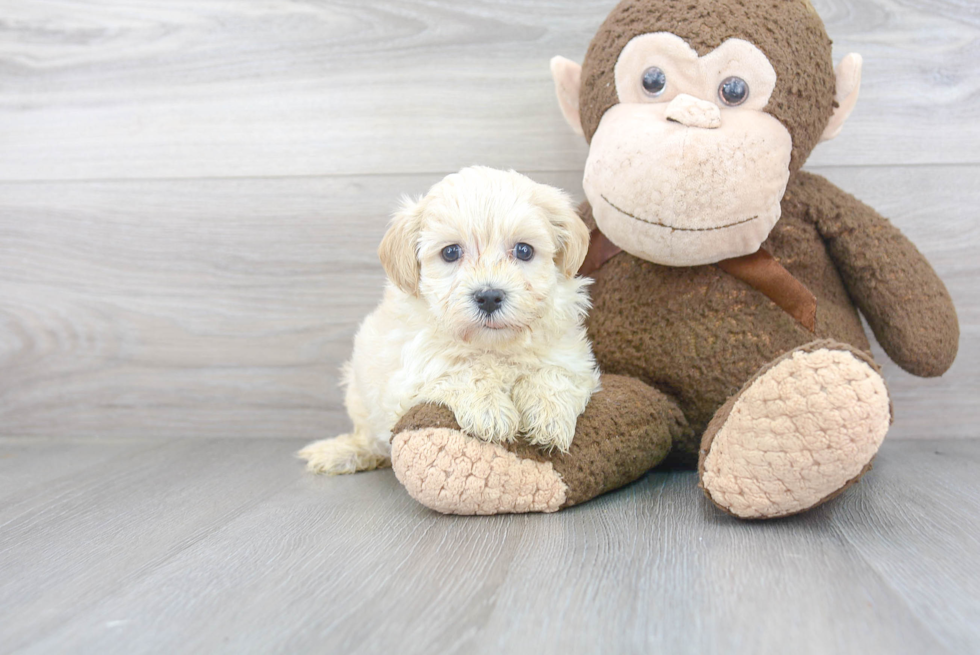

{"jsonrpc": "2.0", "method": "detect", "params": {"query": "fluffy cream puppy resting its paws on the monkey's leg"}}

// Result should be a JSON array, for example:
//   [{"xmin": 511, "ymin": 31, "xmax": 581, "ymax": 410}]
[{"xmin": 299, "ymin": 167, "xmax": 599, "ymax": 473}]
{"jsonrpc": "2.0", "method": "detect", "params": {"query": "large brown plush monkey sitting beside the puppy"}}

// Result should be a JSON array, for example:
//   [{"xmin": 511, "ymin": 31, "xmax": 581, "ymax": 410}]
[{"xmin": 384, "ymin": 0, "xmax": 959, "ymax": 518}]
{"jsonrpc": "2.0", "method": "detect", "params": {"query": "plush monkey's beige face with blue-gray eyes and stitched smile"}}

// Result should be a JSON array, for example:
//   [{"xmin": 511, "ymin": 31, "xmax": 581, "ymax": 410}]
[{"xmin": 584, "ymin": 33, "xmax": 793, "ymax": 266}]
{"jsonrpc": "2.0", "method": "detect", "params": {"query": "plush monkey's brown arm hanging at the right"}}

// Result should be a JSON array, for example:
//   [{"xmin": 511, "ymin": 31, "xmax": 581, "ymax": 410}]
[{"xmin": 785, "ymin": 173, "xmax": 960, "ymax": 377}]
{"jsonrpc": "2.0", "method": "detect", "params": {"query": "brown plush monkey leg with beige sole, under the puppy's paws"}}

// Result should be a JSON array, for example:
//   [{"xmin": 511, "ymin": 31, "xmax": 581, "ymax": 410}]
[{"xmin": 391, "ymin": 375, "xmax": 688, "ymax": 514}]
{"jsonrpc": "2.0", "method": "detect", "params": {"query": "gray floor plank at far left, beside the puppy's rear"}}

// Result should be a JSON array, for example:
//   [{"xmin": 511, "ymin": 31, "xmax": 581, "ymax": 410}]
[{"xmin": 0, "ymin": 439, "xmax": 302, "ymax": 652}]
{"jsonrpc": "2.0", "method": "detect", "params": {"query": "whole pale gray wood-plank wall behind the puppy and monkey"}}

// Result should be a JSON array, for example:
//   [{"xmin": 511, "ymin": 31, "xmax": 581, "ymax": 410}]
[{"xmin": 0, "ymin": 0, "xmax": 980, "ymax": 438}]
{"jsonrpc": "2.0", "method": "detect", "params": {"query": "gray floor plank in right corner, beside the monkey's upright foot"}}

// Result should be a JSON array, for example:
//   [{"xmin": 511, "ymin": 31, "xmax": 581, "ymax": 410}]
[{"xmin": 826, "ymin": 440, "xmax": 980, "ymax": 653}]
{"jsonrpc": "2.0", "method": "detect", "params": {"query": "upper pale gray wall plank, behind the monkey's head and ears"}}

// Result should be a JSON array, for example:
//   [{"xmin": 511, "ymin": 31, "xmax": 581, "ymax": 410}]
[{"xmin": 0, "ymin": 0, "xmax": 980, "ymax": 180}]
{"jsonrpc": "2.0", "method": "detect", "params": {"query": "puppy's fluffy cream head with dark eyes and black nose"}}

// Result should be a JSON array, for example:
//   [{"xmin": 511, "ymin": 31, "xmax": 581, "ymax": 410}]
[{"xmin": 378, "ymin": 166, "xmax": 589, "ymax": 342}]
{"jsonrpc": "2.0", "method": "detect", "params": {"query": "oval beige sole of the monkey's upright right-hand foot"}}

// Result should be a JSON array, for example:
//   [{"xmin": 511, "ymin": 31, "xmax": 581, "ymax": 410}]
[{"xmin": 700, "ymin": 347, "xmax": 891, "ymax": 518}]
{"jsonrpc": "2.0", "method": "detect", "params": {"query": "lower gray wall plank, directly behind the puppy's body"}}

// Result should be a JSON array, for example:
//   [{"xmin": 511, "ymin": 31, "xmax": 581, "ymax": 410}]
[{"xmin": 0, "ymin": 166, "xmax": 980, "ymax": 439}]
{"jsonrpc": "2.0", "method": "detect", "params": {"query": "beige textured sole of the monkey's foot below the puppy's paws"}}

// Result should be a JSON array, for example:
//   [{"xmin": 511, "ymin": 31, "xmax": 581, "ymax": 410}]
[{"xmin": 391, "ymin": 428, "xmax": 567, "ymax": 514}]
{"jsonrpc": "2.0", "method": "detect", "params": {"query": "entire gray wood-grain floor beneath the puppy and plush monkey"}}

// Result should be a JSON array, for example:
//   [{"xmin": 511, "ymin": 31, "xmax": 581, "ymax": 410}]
[{"xmin": 0, "ymin": 439, "xmax": 980, "ymax": 655}]
